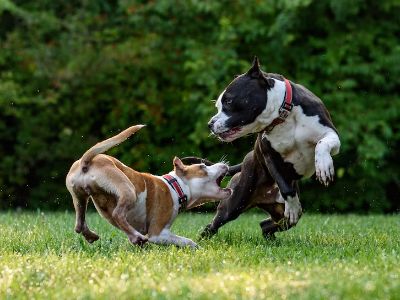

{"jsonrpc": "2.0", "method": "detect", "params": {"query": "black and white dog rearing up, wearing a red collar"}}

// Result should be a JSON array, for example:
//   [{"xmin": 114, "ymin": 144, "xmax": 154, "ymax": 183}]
[{"xmin": 186, "ymin": 57, "xmax": 340, "ymax": 237}]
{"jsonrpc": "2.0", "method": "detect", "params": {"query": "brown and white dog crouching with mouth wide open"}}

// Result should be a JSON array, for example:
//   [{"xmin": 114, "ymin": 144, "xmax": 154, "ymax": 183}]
[{"xmin": 66, "ymin": 125, "xmax": 231, "ymax": 247}]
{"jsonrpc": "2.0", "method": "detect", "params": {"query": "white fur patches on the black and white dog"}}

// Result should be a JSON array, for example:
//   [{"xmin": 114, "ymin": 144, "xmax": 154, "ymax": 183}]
[{"xmin": 213, "ymin": 79, "xmax": 340, "ymax": 224}]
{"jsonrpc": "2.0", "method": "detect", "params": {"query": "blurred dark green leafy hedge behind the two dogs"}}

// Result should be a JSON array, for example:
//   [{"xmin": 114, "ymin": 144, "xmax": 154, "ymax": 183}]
[{"xmin": 0, "ymin": 0, "xmax": 400, "ymax": 212}]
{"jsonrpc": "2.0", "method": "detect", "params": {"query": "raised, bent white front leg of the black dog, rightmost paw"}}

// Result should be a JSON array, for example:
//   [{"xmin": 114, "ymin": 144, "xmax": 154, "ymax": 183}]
[{"xmin": 315, "ymin": 131, "xmax": 340, "ymax": 186}]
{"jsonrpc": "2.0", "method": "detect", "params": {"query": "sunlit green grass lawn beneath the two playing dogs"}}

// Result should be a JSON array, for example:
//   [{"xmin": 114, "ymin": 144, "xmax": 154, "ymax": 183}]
[{"xmin": 0, "ymin": 213, "xmax": 400, "ymax": 299}]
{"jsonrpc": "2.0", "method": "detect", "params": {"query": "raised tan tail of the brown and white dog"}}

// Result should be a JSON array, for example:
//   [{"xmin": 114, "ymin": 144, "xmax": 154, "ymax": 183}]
[{"xmin": 81, "ymin": 125, "xmax": 146, "ymax": 172}]
